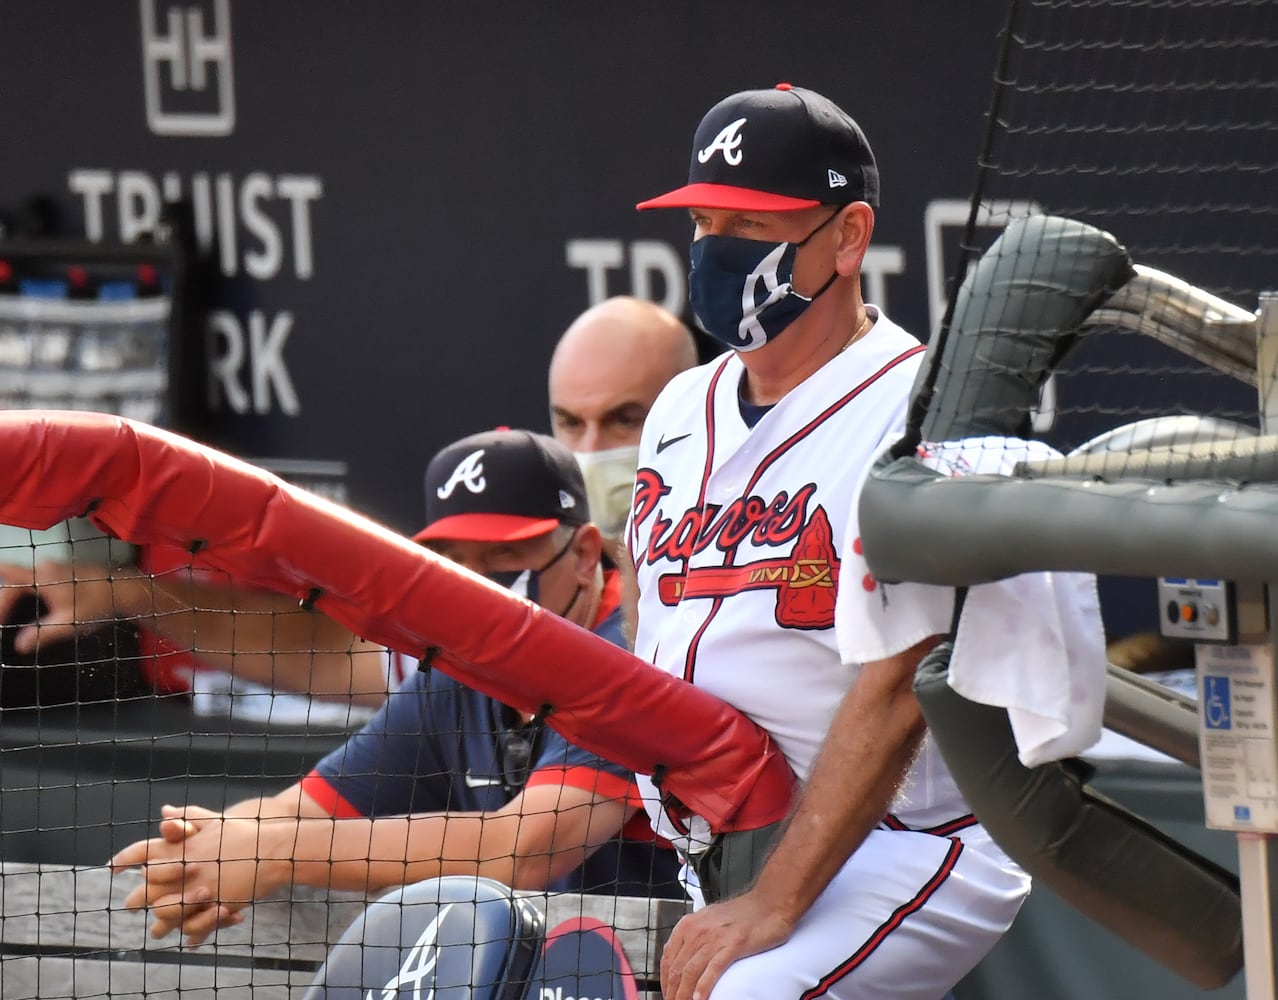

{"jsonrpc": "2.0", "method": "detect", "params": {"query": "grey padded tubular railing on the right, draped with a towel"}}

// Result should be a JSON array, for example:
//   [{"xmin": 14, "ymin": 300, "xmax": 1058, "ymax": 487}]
[{"xmin": 860, "ymin": 216, "xmax": 1278, "ymax": 997}]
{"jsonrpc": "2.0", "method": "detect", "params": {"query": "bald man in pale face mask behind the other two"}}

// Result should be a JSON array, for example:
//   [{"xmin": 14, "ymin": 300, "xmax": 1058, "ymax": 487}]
[{"xmin": 550, "ymin": 295, "xmax": 698, "ymax": 551}]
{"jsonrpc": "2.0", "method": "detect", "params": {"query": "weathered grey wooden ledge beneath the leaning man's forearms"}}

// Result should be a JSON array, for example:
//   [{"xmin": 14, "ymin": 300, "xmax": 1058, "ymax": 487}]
[{"xmin": 0, "ymin": 863, "xmax": 685, "ymax": 1000}]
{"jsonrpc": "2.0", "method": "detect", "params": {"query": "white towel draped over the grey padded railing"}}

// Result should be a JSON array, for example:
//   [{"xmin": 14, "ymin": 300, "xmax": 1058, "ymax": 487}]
[{"xmin": 835, "ymin": 437, "xmax": 1105, "ymax": 767}]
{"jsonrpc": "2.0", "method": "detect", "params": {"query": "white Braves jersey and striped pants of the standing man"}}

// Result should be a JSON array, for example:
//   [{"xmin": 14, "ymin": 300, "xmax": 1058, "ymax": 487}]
[{"xmin": 626, "ymin": 307, "xmax": 1029, "ymax": 1000}]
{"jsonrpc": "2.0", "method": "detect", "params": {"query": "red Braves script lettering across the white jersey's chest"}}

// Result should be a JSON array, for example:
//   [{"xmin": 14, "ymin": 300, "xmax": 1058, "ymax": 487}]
[{"xmin": 634, "ymin": 469, "xmax": 817, "ymax": 565}]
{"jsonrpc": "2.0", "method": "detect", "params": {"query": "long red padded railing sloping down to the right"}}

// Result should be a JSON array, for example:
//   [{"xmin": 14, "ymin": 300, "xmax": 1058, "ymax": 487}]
[{"xmin": 0, "ymin": 410, "xmax": 795, "ymax": 831}]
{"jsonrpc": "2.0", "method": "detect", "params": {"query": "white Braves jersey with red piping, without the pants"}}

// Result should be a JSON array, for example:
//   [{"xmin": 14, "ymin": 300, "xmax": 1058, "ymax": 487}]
[{"xmin": 629, "ymin": 309, "xmax": 966, "ymax": 834}]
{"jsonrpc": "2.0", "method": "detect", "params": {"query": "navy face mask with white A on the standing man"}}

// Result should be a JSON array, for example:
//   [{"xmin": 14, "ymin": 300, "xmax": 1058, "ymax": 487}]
[{"xmin": 688, "ymin": 208, "xmax": 842, "ymax": 352}]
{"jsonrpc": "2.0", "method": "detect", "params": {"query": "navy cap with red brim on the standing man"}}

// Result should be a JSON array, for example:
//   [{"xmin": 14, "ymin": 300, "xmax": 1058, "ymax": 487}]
[{"xmin": 635, "ymin": 83, "xmax": 878, "ymax": 212}]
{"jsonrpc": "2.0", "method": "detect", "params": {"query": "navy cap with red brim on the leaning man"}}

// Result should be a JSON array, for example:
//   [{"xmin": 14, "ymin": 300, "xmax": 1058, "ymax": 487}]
[{"xmin": 413, "ymin": 428, "xmax": 590, "ymax": 542}]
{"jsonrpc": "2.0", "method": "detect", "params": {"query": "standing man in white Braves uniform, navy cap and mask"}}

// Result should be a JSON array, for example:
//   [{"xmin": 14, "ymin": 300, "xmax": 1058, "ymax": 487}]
[{"xmin": 626, "ymin": 84, "xmax": 1029, "ymax": 1000}]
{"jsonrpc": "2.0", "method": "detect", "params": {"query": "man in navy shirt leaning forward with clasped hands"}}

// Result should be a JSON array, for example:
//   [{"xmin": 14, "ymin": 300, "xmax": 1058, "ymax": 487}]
[{"xmin": 112, "ymin": 430, "xmax": 681, "ymax": 941}]
